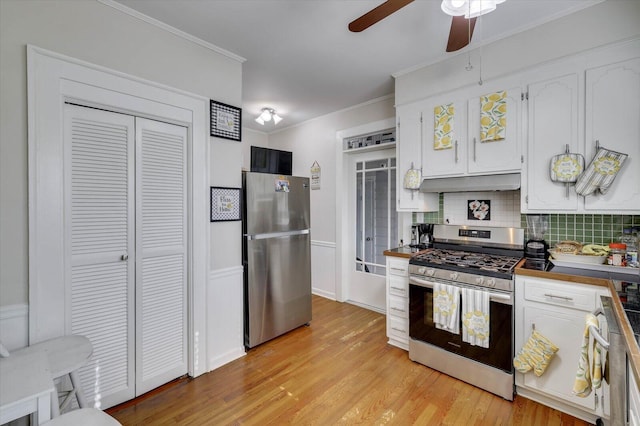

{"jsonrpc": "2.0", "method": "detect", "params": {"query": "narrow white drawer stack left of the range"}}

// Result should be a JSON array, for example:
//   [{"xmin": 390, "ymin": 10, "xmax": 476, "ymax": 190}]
[{"xmin": 387, "ymin": 256, "xmax": 409, "ymax": 350}]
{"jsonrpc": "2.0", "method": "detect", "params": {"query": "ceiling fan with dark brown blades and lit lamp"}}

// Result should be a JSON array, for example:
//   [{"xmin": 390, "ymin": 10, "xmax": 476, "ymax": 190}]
[{"xmin": 349, "ymin": 0, "xmax": 492, "ymax": 52}]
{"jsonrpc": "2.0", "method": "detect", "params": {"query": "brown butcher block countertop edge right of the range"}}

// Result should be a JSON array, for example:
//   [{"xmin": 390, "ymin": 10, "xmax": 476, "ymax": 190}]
[{"xmin": 516, "ymin": 259, "xmax": 640, "ymax": 383}]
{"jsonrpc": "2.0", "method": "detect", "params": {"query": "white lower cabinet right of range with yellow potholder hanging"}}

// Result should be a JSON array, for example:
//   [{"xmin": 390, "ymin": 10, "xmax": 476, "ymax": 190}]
[{"xmin": 515, "ymin": 277, "xmax": 609, "ymax": 422}]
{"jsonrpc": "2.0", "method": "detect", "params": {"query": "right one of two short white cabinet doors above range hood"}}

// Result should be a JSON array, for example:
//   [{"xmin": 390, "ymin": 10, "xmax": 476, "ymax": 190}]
[{"xmin": 468, "ymin": 87, "xmax": 522, "ymax": 174}]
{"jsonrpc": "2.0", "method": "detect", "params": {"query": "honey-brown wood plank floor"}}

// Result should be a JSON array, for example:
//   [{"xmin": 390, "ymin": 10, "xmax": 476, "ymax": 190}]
[{"xmin": 107, "ymin": 296, "xmax": 588, "ymax": 426}]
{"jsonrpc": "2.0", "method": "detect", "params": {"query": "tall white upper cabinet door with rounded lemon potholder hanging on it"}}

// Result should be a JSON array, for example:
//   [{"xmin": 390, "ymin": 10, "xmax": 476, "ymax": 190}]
[{"xmin": 522, "ymin": 74, "xmax": 580, "ymax": 212}]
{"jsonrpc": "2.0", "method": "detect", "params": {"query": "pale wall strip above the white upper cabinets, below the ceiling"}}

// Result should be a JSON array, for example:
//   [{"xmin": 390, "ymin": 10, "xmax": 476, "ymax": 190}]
[{"xmin": 395, "ymin": 0, "xmax": 640, "ymax": 105}]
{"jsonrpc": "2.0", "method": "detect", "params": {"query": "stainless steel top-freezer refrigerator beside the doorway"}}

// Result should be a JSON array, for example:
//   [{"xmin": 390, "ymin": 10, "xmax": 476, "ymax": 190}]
[{"xmin": 242, "ymin": 172, "xmax": 311, "ymax": 349}]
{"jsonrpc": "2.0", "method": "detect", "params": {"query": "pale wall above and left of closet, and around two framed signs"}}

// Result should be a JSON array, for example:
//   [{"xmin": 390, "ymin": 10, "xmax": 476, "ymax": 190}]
[{"xmin": 0, "ymin": 0, "xmax": 242, "ymax": 306}]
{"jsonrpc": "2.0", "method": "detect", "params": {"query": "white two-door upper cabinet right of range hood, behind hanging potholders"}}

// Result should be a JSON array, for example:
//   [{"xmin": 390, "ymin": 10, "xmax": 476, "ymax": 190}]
[{"xmin": 522, "ymin": 52, "xmax": 640, "ymax": 214}]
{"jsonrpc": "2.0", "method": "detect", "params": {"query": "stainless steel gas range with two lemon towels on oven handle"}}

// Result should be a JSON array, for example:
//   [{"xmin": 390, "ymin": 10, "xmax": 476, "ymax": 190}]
[{"xmin": 409, "ymin": 225, "xmax": 524, "ymax": 401}]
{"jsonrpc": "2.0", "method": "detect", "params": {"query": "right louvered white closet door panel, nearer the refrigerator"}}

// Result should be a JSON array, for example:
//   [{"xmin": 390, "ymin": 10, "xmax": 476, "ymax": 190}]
[{"xmin": 136, "ymin": 118, "xmax": 187, "ymax": 395}]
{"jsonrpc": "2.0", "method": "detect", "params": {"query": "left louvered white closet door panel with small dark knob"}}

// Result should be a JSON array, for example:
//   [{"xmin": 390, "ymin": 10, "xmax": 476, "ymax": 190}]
[{"xmin": 65, "ymin": 105, "xmax": 135, "ymax": 407}]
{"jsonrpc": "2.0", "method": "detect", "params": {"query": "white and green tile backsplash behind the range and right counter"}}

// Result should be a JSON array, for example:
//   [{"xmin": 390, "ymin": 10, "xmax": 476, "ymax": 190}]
[{"xmin": 412, "ymin": 191, "xmax": 640, "ymax": 246}]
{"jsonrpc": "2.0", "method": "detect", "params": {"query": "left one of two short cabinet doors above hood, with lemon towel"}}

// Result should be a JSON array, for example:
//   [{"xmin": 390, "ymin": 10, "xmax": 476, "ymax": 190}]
[{"xmin": 422, "ymin": 97, "xmax": 467, "ymax": 177}]
